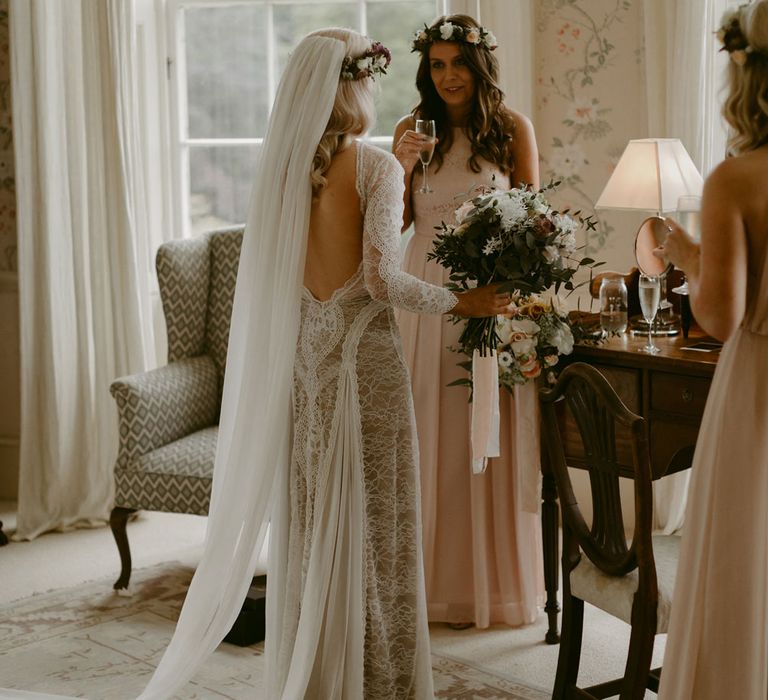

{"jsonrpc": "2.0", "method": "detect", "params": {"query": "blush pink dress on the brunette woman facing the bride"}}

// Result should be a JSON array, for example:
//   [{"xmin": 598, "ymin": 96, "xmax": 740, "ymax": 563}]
[{"xmin": 398, "ymin": 128, "xmax": 543, "ymax": 628}]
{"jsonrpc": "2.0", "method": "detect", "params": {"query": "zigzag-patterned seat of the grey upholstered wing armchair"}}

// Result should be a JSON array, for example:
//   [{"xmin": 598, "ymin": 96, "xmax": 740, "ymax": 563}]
[{"xmin": 115, "ymin": 426, "xmax": 218, "ymax": 515}]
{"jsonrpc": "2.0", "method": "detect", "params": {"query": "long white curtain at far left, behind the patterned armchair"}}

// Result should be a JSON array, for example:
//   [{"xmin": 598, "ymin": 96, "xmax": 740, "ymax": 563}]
[{"xmin": 10, "ymin": 0, "xmax": 152, "ymax": 539}]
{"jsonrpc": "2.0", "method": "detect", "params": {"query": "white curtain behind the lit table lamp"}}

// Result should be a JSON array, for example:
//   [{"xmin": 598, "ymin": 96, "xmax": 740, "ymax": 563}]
[{"xmin": 644, "ymin": 0, "xmax": 733, "ymax": 534}]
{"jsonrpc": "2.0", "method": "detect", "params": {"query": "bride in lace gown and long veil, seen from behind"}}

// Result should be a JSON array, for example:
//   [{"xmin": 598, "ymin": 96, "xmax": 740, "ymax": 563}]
[{"xmin": 0, "ymin": 29, "xmax": 508, "ymax": 700}]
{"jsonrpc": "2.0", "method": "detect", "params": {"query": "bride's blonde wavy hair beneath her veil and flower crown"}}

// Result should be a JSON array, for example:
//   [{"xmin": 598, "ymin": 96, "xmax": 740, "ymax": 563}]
[{"xmin": 310, "ymin": 27, "xmax": 376, "ymax": 197}]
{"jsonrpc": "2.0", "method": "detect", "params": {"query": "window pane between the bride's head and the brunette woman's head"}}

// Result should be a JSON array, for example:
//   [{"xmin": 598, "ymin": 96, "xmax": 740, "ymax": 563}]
[{"xmin": 368, "ymin": 0, "xmax": 435, "ymax": 136}]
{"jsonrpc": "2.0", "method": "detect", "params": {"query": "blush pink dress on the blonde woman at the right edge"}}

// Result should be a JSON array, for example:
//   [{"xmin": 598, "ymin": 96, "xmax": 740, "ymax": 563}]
[{"xmin": 659, "ymin": 211, "xmax": 768, "ymax": 700}]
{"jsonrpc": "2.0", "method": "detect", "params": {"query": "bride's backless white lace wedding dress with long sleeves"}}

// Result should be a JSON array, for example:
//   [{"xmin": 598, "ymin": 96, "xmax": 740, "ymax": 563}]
[{"xmin": 268, "ymin": 143, "xmax": 456, "ymax": 700}]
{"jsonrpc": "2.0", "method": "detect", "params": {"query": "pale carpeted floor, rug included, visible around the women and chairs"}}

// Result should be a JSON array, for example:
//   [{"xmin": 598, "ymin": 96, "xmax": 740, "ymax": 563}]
[{"xmin": 0, "ymin": 502, "xmax": 665, "ymax": 700}]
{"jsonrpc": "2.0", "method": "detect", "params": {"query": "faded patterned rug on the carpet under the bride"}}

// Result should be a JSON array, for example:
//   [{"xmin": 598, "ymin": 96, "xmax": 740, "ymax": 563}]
[{"xmin": 0, "ymin": 564, "xmax": 548, "ymax": 700}]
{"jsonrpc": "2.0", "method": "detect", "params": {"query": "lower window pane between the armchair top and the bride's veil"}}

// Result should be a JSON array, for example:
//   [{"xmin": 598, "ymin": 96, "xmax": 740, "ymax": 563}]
[{"xmin": 189, "ymin": 146, "xmax": 260, "ymax": 235}]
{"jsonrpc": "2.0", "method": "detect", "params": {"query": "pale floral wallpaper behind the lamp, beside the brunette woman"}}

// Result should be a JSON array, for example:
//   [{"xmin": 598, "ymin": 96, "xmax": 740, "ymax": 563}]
[{"xmin": 534, "ymin": 0, "xmax": 648, "ymax": 286}]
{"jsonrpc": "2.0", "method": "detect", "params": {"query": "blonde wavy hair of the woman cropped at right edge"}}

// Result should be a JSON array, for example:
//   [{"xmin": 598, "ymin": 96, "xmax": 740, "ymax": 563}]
[{"xmin": 723, "ymin": 0, "xmax": 768, "ymax": 155}]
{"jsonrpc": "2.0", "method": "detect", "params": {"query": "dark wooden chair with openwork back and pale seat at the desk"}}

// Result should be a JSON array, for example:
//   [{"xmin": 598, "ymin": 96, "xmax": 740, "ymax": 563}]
[{"xmin": 539, "ymin": 362, "xmax": 679, "ymax": 700}]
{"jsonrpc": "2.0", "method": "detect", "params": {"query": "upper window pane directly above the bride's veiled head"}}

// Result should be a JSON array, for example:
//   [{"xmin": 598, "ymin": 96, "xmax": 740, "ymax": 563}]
[{"xmin": 274, "ymin": 2, "xmax": 359, "ymax": 77}]
